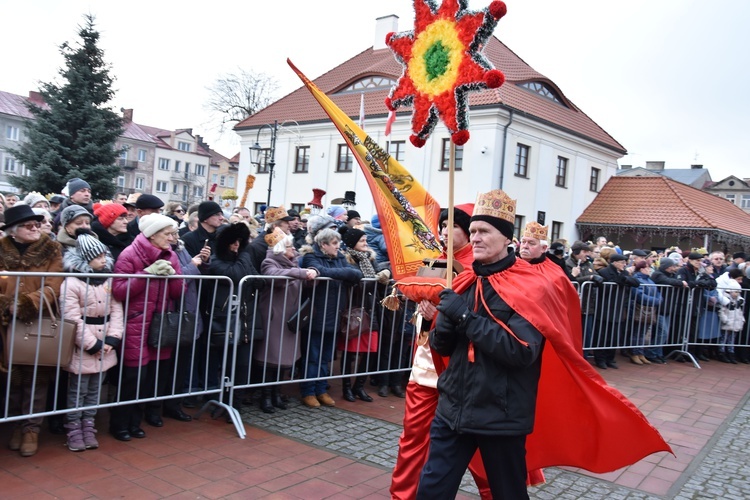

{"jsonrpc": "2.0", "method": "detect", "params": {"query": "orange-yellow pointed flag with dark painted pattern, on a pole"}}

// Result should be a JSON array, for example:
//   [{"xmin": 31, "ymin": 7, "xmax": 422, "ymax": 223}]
[{"xmin": 287, "ymin": 59, "xmax": 441, "ymax": 279}]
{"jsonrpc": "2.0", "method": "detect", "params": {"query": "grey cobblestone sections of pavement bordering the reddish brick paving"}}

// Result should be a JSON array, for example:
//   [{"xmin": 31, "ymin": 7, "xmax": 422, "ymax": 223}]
[{"xmin": 243, "ymin": 395, "xmax": 750, "ymax": 500}]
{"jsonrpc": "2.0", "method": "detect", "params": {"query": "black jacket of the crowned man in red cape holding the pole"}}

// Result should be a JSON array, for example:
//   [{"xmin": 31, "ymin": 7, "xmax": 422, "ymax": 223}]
[{"xmin": 430, "ymin": 253, "xmax": 544, "ymax": 436}]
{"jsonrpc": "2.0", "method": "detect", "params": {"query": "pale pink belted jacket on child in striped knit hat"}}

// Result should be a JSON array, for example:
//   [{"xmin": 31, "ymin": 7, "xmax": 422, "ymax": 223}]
[{"xmin": 60, "ymin": 277, "xmax": 124, "ymax": 374}]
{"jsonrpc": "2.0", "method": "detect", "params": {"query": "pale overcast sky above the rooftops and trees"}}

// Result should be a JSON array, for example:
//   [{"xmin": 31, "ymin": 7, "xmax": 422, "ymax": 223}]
[{"xmin": 0, "ymin": 0, "xmax": 750, "ymax": 181}]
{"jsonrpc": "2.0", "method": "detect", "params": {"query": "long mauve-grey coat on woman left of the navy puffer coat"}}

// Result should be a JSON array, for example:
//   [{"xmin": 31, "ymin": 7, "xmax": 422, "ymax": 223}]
[{"xmin": 253, "ymin": 248, "xmax": 307, "ymax": 368}]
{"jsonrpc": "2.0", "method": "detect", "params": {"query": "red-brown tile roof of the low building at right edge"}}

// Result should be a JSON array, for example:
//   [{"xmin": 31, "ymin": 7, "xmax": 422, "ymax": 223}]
[{"xmin": 576, "ymin": 176, "xmax": 750, "ymax": 237}]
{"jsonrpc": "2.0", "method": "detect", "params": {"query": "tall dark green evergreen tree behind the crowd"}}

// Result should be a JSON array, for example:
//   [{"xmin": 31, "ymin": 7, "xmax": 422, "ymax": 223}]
[{"xmin": 10, "ymin": 15, "xmax": 122, "ymax": 199}]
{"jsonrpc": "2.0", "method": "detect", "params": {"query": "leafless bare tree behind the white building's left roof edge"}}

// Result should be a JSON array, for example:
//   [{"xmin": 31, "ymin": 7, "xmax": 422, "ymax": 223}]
[{"xmin": 205, "ymin": 68, "xmax": 279, "ymax": 133}]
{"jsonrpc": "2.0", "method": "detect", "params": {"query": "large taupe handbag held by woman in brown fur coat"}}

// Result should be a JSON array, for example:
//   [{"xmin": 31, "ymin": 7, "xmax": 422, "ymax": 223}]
[{"xmin": 4, "ymin": 287, "xmax": 78, "ymax": 367}]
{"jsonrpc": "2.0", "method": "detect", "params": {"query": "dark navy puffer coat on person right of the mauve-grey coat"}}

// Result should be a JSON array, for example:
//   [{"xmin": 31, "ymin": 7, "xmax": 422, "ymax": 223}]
[{"xmin": 300, "ymin": 243, "xmax": 362, "ymax": 333}]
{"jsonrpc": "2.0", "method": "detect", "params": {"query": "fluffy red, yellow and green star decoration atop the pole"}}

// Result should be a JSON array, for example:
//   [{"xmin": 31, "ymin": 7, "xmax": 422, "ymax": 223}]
[{"xmin": 385, "ymin": 0, "xmax": 506, "ymax": 148}]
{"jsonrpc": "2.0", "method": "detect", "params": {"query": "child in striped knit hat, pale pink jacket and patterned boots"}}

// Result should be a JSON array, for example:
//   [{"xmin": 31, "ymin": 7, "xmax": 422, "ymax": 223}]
[{"xmin": 61, "ymin": 230, "xmax": 123, "ymax": 451}]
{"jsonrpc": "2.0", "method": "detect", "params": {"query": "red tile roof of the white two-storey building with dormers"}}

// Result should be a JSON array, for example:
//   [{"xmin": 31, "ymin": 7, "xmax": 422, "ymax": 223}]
[{"xmin": 235, "ymin": 37, "xmax": 627, "ymax": 154}]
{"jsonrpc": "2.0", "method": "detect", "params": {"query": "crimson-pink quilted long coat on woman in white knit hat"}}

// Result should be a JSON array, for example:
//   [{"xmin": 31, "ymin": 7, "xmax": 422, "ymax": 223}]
[{"xmin": 112, "ymin": 234, "xmax": 184, "ymax": 367}]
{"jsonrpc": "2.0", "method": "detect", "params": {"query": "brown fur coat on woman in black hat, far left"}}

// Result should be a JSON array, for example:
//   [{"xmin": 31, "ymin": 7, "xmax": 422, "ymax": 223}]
[{"xmin": 0, "ymin": 234, "xmax": 63, "ymax": 325}]
